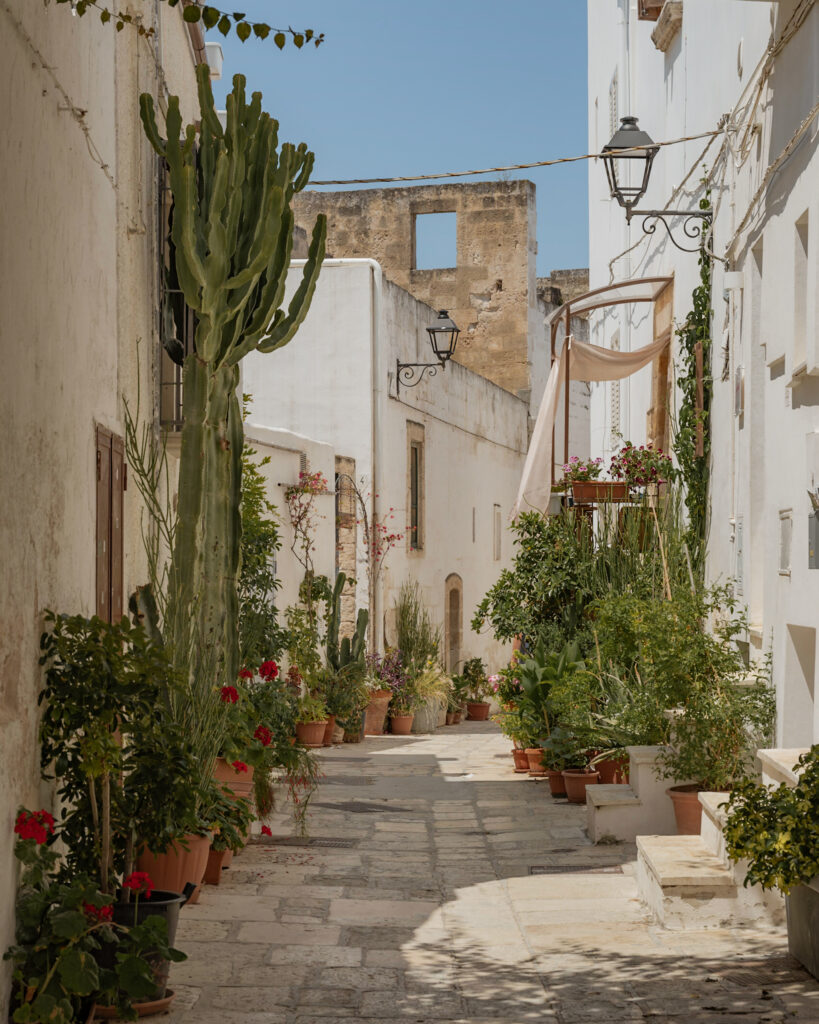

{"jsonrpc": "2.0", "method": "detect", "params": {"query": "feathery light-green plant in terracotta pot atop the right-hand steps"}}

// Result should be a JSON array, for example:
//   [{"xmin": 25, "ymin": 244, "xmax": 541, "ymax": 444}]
[{"xmin": 658, "ymin": 667, "xmax": 776, "ymax": 836}]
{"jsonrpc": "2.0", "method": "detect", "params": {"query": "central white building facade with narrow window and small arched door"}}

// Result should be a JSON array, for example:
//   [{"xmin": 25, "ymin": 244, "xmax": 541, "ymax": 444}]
[{"xmin": 243, "ymin": 259, "xmax": 528, "ymax": 671}]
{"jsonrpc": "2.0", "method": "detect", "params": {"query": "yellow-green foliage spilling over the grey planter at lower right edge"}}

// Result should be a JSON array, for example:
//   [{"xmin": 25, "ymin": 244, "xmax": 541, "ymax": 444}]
[{"xmin": 723, "ymin": 745, "xmax": 819, "ymax": 893}]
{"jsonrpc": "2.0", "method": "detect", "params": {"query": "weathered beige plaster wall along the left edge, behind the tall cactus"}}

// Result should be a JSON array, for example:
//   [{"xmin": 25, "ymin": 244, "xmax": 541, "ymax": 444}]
[{"xmin": 0, "ymin": 0, "xmax": 197, "ymax": 1017}]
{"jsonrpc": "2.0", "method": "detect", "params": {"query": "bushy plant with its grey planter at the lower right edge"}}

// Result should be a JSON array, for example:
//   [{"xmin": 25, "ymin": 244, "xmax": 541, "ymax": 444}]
[{"xmin": 723, "ymin": 745, "xmax": 819, "ymax": 978}]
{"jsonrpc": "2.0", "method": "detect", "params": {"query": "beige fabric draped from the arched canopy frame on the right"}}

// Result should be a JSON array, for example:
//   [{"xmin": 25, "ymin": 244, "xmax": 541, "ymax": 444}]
[{"xmin": 512, "ymin": 335, "xmax": 670, "ymax": 519}]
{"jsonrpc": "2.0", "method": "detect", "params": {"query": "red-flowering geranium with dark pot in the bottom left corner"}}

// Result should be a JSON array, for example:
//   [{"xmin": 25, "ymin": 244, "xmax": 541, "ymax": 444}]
[{"xmin": 3, "ymin": 809, "xmax": 185, "ymax": 1024}]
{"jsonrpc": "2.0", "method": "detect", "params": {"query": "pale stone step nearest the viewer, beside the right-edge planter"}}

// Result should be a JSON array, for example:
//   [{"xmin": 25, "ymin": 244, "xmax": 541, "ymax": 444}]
[{"xmin": 637, "ymin": 835, "xmax": 783, "ymax": 930}]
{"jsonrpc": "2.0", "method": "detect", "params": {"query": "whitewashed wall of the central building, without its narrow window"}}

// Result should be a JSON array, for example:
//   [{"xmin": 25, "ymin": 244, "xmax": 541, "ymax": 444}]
[{"xmin": 244, "ymin": 260, "xmax": 527, "ymax": 668}]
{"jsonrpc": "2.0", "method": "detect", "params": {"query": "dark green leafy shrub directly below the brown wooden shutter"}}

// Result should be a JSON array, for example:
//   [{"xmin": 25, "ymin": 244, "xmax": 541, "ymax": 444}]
[{"xmin": 39, "ymin": 611, "xmax": 197, "ymax": 893}]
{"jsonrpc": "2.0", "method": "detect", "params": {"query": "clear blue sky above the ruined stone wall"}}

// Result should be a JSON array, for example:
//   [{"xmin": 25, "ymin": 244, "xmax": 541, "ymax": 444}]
[{"xmin": 208, "ymin": 0, "xmax": 589, "ymax": 275}]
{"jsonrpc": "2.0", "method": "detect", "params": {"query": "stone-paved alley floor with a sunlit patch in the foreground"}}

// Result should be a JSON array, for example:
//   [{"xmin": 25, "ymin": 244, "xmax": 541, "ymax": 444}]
[{"xmin": 165, "ymin": 722, "xmax": 819, "ymax": 1024}]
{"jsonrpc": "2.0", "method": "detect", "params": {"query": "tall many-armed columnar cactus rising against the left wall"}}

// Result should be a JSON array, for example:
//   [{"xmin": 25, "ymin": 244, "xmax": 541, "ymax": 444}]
[{"xmin": 140, "ymin": 65, "xmax": 327, "ymax": 683}]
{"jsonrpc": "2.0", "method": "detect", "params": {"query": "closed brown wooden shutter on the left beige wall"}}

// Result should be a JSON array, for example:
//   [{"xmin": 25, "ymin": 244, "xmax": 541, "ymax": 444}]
[{"xmin": 96, "ymin": 427, "xmax": 126, "ymax": 623}]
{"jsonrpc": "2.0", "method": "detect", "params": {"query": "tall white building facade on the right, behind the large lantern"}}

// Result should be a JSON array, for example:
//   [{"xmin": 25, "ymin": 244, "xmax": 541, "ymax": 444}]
[{"xmin": 589, "ymin": 0, "xmax": 819, "ymax": 746}]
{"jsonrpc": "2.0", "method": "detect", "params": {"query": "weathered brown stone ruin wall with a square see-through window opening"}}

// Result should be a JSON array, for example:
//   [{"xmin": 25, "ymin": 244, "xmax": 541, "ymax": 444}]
[{"xmin": 294, "ymin": 180, "xmax": 543, "ymax": 393}]
